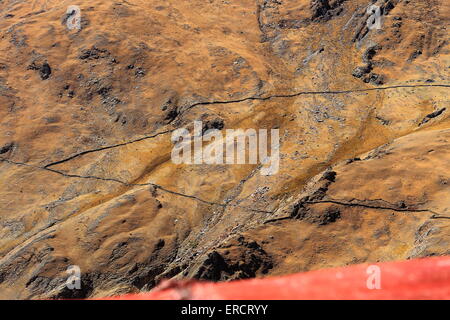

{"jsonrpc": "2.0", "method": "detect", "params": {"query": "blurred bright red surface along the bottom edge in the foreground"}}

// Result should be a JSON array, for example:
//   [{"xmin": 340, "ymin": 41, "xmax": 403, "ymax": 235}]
[{"xmin": 103, "ymin": 257, "xmax": 450, "ymax": 300}]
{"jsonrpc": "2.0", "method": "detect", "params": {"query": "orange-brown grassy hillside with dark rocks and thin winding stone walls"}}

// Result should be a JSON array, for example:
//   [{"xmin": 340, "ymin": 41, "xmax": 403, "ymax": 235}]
[{"xmin": 0, "ymin": 0, "xmax": 450, "ymax": 299}]
